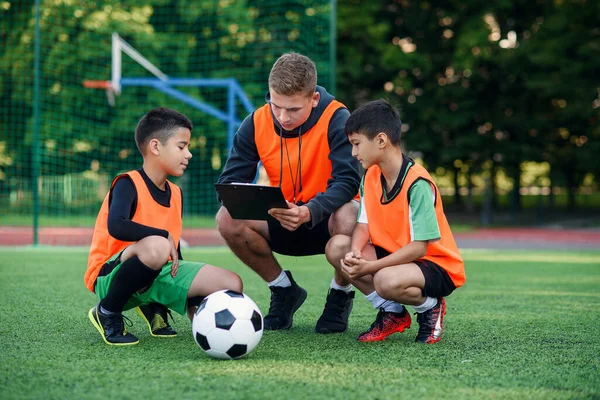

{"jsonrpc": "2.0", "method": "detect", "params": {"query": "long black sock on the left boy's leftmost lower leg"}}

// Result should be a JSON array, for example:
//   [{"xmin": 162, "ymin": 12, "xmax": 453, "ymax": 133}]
[{"xmin": 100, "ymin": 256, "xmax": 160, "ymax": 313}]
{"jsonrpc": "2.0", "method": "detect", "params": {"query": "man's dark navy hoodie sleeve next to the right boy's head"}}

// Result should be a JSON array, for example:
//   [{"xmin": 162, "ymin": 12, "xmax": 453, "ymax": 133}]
[{"xmin": 306, "ymin": 108, "xmax": 360, "ymax": 228}]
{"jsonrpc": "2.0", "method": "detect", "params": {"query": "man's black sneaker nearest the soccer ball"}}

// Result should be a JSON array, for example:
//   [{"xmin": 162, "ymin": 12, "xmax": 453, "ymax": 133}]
[{"xmin": 264, "ymin": 271, "xmax": 306, "ymax": 331}]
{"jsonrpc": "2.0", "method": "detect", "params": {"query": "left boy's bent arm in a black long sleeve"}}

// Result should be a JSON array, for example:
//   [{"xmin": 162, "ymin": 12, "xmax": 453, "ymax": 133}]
[{"xmin": 108, "ymin": 176, "xmax": 169, "ymax": 242}]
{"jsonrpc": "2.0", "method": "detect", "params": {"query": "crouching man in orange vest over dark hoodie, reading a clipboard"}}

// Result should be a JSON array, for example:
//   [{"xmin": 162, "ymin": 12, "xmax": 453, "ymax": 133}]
[{"xmin": 216, "ymin": 53, "xmax": 360, "ymax": 333}]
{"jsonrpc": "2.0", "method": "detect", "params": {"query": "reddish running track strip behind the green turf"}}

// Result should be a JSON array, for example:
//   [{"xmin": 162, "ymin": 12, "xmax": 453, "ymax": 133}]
[{"xmin": 0, "ymin": 226, "xmax": 600, "ymax": 249}]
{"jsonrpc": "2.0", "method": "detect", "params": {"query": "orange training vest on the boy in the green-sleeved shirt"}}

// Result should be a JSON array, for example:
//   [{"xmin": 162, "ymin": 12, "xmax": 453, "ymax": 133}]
[{"xmin": 363, "ymin": 164, "xmax": 466, "ymax": 288}]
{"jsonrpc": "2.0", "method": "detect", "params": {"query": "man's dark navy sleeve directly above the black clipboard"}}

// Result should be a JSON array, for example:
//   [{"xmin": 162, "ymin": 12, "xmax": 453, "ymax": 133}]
[{"xmin": 217, "ymin": 113, "xmax": 259, "ymax": 191}]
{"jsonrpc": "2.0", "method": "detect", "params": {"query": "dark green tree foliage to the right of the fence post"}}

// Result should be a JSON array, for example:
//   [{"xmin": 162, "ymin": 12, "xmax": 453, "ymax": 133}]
[{"xmin": 338, "ymin": 0, "xmax": 600, "ymax": 209}]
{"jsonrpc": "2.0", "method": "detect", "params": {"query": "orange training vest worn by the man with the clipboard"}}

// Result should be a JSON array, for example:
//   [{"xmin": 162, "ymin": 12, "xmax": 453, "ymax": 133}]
[{"xmin": 253, "ymin": 100, "xmax": 345, "ymax": 203}]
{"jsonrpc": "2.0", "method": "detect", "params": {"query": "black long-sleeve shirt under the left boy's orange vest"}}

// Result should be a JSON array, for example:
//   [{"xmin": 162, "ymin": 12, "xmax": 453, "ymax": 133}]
[{"xmin": 108, "ymin": 168, "xmax": 183, "ymax": 260}]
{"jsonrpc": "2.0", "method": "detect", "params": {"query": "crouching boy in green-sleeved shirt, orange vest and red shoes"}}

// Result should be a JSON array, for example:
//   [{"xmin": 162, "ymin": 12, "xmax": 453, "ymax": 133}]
[{"xmin": 326, "ymin": 100, "xmax": 465, "ymax": 343}]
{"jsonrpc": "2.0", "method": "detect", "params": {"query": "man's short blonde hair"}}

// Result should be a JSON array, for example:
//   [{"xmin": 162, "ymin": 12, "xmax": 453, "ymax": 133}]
[{"xmin": 269, "ymin": 52, "xmax": 317, "ymax": 96}]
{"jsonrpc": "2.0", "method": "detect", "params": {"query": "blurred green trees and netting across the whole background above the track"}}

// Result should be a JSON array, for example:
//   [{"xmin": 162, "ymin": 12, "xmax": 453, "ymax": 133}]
[{"xmin": 0, "ymin": 0, "xmax": 600, "ymax": 231}]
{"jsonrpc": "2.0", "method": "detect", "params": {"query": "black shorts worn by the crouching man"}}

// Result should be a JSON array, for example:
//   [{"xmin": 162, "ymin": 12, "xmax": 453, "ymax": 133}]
[{"xmin": 267, "ymin": 216, "xmax": 331, "ymax": 256}]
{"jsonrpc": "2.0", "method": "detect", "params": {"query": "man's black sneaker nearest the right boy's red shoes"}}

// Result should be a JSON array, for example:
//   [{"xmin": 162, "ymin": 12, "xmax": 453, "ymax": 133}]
[{"xmin": 315, "ymin": 289, "xmax": 355, "ymax": 333}]
